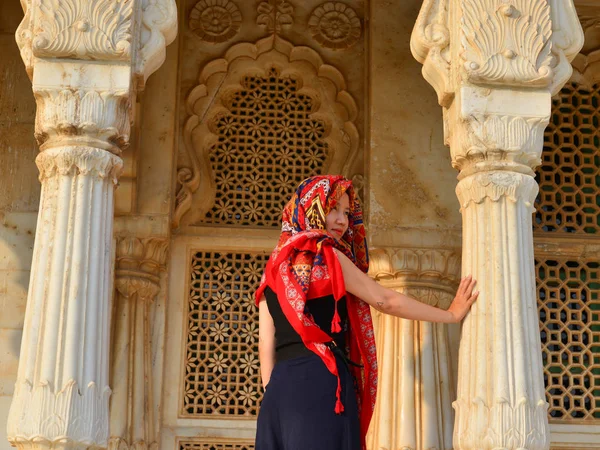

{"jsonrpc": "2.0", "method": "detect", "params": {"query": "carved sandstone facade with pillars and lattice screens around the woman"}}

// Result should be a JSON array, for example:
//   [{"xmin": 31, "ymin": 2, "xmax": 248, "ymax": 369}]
[{"xmin": 0, "ymin": 0, "xmax": 600, "ymax": 450}]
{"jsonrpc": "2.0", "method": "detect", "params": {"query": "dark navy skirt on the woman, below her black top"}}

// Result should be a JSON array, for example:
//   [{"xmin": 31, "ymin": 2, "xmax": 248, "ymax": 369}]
[{"xmin": 255, "ymin": 354, "xmax": 361, "ymax": 450}]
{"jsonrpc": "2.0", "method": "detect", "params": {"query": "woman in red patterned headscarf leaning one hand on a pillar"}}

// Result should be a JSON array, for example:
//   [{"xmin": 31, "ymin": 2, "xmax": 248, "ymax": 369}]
[{"xmin": 255, "ymin": 176, "xmax": 478, "ymax": 450}]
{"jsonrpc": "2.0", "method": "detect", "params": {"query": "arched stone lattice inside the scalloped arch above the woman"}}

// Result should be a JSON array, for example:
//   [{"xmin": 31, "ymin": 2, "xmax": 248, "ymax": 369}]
[{"xmin": 202, "ymin": 69, "xmax": 328, "ymax": 227}]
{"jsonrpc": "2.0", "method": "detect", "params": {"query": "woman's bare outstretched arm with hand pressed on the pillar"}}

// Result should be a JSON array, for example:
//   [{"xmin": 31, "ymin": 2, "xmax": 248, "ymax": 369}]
[{"xmin": 336, "ymin": 250, "xmax": 479, "ymax": 323}]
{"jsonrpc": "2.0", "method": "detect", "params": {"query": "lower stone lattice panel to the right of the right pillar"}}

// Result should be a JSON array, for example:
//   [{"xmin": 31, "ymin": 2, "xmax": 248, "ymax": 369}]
[{"xmin": 536, "ymin": 258, "xmax": 600, "ymax": 421}]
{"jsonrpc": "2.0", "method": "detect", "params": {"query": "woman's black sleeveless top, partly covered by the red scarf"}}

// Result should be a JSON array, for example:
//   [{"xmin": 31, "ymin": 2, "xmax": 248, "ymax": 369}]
[{"xmin": 265, "ymin": 286, "xmax": 348, "ymax": 361}]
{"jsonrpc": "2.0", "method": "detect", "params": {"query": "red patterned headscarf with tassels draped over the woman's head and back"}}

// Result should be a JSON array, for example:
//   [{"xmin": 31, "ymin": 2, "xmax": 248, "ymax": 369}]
[{"xmin": 256, "ymin": 176, "xmax": 377, "ymax": 448}]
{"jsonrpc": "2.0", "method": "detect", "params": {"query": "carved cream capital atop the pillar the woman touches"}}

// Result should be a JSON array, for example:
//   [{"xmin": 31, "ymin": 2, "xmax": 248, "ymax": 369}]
[{"xmin": 411, "ymin": 0, "xmax": 583, "ymax": 176}]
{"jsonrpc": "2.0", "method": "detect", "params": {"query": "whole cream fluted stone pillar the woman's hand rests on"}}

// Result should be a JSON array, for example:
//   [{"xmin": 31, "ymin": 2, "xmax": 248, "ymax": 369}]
[{"xmin": 411, "ymin": 0, "xmax": 583, "ymax": 450}]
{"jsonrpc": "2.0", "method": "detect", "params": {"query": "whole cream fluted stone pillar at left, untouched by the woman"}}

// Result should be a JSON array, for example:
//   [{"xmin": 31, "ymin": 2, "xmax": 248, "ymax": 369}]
[{"xmin": 7, "ymin": 0, "xmax": 176, "ymax": 448}]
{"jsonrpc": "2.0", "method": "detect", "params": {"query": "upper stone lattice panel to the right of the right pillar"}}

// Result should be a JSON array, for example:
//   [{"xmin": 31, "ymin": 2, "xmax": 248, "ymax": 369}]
[{"xmin": 534, "ymin": 83, "xmax": 600, "ymax": 233}]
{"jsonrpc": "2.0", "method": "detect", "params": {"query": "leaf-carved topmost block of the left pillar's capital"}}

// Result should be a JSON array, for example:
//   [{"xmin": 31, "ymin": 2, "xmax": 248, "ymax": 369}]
[{"xmin": 16, "ymin": 0, "xmax": 177, "ymax": 84}]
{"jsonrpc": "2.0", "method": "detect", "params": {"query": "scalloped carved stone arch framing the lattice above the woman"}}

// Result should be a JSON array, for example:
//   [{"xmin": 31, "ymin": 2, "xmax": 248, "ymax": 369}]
[{"xmin": 173, "ymin": 36, "xmax": 359, "ymax": 227}]
